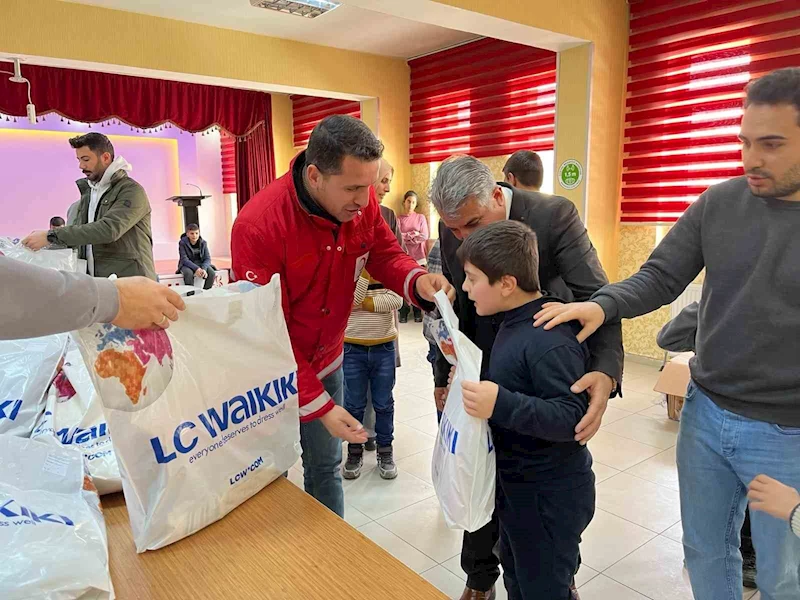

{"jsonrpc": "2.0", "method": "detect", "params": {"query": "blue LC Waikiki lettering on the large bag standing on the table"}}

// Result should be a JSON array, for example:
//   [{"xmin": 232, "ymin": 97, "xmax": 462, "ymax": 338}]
[{"xmin": 150, "ymin": 371, "xmax": 297, "ymax": 464}]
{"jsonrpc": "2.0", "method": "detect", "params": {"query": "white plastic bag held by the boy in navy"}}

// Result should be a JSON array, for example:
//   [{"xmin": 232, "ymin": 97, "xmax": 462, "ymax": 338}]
[{"xmin": 431, "ymin": 292, "xmax": 496, "ymax": 532}]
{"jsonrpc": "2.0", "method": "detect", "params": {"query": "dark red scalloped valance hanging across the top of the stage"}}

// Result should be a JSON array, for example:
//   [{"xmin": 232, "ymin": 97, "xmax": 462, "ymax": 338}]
[{"xmin": 0, "ymin": 62, "xmax": 270, "ymax": 137}]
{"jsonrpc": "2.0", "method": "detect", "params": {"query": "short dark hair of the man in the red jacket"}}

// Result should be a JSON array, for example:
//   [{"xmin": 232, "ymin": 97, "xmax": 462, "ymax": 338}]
[{"xmin": 306, "ymin": 115, "xmax": 383, "ymax": 175}]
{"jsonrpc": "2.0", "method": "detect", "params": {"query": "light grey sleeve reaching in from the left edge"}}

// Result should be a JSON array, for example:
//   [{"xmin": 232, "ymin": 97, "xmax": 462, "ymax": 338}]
[{"xmin": 0, "ymin": 255, "xmax": 119, "ymax": 340}]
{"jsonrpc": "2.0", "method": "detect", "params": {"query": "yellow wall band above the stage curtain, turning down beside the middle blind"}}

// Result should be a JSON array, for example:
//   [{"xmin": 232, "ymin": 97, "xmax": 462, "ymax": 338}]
[{"xmin": 0, "ymin": 0, "xmax": 410, "ymax": 197}]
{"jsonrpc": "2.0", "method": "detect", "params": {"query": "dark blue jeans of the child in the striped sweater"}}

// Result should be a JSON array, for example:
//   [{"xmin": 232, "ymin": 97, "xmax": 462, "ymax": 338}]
[{"xmin": 344, "ymin": 342, "xmax": 395, "ymax": 447}]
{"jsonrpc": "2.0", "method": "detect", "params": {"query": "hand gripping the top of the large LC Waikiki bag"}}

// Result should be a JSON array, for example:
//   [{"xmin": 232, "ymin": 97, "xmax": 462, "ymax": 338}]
[{"xmin": 111, "ymin": 277, "xmax": 186, "ymax": 329}]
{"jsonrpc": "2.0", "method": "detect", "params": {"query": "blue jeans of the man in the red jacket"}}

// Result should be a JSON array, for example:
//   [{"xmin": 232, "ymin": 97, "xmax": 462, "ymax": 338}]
[{"xmin": 300, "ymin": 369, "xmax": 344, "ymax": 518}]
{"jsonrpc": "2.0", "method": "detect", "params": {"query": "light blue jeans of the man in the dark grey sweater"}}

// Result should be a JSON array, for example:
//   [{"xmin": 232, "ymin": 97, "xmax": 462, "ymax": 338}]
[{"xmin": 677, "ymin": 382, "xmax": 800, "ymax": 600}]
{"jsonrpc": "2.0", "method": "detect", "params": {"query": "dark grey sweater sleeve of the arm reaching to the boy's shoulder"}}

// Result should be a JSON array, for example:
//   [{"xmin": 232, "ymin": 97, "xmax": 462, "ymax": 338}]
[{"xmin": 592, "ymin": 192, "xmax": 708, "ymax": 323}]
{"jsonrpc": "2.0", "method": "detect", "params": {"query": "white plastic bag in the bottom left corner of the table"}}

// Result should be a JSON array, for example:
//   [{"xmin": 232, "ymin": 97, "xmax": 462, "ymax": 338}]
[{"xmin": 0, "ymin": 435, "xmax": 114, "ymax": 600}]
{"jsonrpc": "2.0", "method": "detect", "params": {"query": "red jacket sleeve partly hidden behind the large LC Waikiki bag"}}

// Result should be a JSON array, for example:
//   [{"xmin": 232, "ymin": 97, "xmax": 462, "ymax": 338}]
[{"xmin": 231, "ymin": 221, "xmax": 334, "ymax": 423}]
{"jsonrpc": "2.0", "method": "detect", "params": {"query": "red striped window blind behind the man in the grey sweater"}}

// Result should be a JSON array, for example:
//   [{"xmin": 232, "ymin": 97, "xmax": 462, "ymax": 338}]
[{"xmin": 622, "ymin": 0, "xmax": 800, "ymax": 223}]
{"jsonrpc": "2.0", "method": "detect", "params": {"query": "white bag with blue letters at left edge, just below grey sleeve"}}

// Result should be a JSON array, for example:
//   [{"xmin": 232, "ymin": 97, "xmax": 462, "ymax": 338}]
[{"xmin": 0, "ymin": 334, "xmax": 67, "ymax": 437}]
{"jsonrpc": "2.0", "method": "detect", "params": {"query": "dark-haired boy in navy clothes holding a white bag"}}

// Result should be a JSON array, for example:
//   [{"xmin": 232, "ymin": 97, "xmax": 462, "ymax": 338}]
[{"xmin": 458, "ymin": 221, "xmax": 595, "ymax": 600}]
